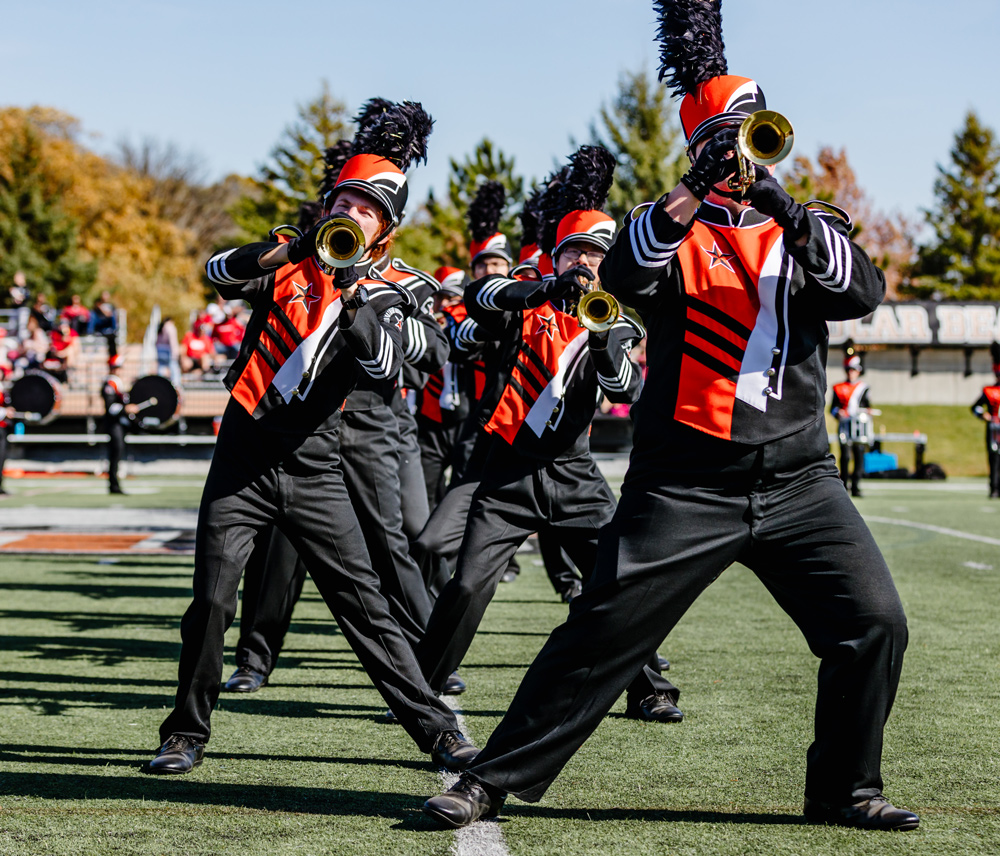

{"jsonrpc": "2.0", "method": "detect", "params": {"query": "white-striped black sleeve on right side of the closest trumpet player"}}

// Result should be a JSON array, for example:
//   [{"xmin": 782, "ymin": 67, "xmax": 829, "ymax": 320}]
[{"xmin": 785, "ymin": 209, "xmax": 885, "ymax": 321}]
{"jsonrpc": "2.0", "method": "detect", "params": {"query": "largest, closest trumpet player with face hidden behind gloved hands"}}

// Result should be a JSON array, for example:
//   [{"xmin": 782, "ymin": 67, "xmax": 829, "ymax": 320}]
[{"xmin": 425, "ymin": 0, "xmax": 919, "ymax": 830}]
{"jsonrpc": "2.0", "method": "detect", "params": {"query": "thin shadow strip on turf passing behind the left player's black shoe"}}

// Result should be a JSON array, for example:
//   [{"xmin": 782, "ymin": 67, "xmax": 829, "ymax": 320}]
[{"xmin": 0, "ymin": 743, "xmax": 432, "ymax": 781}]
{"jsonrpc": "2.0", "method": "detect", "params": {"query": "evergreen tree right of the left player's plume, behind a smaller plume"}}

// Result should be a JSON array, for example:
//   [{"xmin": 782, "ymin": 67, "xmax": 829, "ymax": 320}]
[{"xmin": 393, "ymin": 138, "xmax": 524, "ymax": 271}]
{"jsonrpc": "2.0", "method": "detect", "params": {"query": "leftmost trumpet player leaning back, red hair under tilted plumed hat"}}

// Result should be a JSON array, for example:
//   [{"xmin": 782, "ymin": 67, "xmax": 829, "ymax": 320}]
[{"xmin": 147, "ymin": 102, "xmax": 476, "ymax": 773}]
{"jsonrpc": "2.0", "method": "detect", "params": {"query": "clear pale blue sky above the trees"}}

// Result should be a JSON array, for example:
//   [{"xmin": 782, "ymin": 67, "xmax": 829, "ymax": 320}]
[{"xmin": 0, "ymin": 0, "xmax": 1000, "ymax": 227}]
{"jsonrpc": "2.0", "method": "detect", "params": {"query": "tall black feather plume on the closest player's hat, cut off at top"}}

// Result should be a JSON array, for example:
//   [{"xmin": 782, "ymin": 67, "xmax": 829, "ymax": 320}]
[{"xmin": 653, "ymin": 0, "xmax": 728, "ymax": 98}]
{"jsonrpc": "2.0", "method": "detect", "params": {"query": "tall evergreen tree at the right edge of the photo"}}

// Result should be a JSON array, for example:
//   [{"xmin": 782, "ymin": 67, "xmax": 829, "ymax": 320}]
[{"xmin": 908, "ymin": 112, "xmax": 1000, "ymax": 300}]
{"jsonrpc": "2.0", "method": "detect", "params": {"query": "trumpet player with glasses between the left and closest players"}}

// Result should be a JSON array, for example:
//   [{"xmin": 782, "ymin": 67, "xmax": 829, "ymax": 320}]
[{"xmin": 417, "ymin": 146, "xmax": 683, "ymax": 722}]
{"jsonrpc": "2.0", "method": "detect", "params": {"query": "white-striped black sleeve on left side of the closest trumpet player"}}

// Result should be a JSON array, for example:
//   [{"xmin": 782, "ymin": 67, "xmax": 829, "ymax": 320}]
[{"xmin": 599, "ymin": 200, "xmax": 691, "ymax": 310}]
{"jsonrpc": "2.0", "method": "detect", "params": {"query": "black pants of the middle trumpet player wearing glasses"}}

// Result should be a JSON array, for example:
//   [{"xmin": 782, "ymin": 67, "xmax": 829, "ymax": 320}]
[{"xmin": 417, "ymin": 452, "xmax": 679, "ymax": 701}]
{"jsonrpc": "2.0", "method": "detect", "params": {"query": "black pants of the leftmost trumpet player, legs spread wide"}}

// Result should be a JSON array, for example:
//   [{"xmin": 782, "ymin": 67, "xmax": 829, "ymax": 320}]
[{"xmin": 160, "ymin": 416, "xmax": 457, "ymax": 752}]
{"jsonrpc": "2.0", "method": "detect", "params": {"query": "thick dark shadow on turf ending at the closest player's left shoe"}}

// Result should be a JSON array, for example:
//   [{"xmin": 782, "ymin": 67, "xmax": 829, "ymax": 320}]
[{"xmin": 0, "ymin": 773, "xmax": 426, "ymax": 816}]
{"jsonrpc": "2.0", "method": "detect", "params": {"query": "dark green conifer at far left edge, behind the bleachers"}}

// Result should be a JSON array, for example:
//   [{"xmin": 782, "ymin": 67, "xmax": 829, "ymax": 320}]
[{"xmin": 0, "ymin": 116, "xmax": 97, "ymax": 303}]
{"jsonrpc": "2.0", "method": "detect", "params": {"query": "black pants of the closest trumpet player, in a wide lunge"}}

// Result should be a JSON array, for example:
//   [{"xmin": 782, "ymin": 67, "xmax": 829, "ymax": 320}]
[{"xmin": 471, "ymin": 442, "xmax": 907, "ymax": 804}]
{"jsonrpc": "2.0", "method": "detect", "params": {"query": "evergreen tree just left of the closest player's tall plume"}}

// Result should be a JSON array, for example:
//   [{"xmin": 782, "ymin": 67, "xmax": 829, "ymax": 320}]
[{"xmin": 591, "ymin": 71, "xmax": 688, "ymax": 223}]
